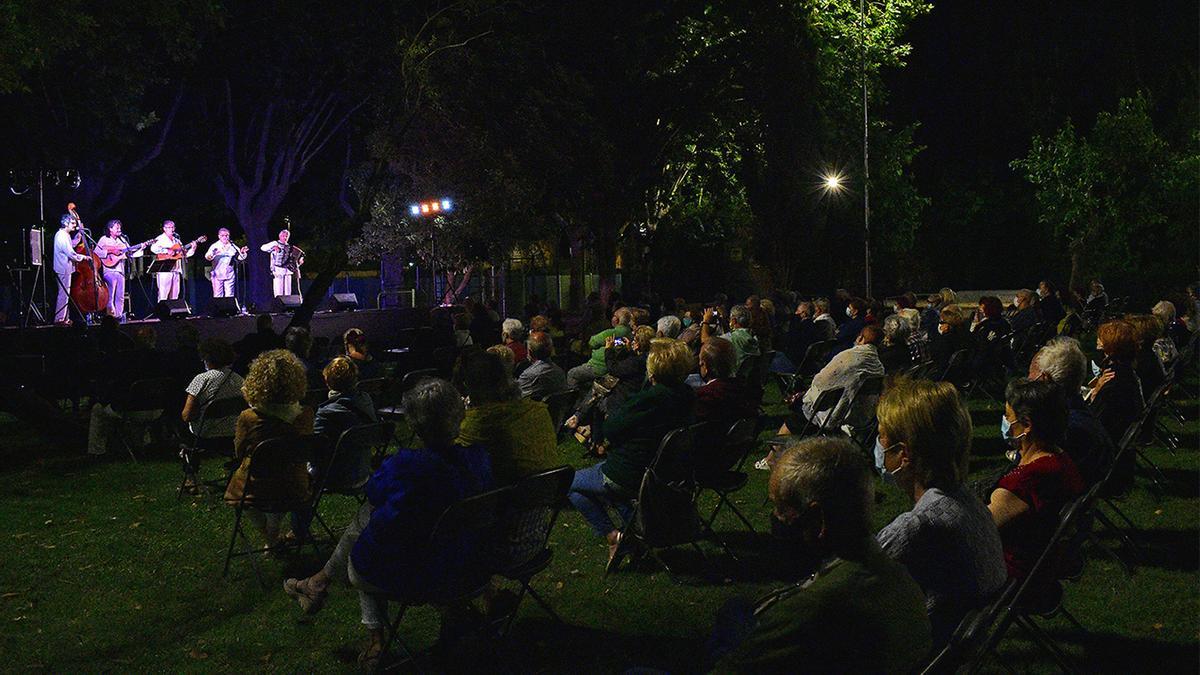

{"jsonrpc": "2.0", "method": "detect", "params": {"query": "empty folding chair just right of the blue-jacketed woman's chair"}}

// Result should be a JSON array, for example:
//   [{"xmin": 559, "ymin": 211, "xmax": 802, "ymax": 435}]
[{"xmin": 498, "ymin": 466, "xmax": 575, "ymax": 637}]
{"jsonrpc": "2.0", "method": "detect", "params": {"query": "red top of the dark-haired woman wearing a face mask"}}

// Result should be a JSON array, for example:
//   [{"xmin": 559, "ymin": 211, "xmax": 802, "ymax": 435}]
[{"xmin": 996, "ymin": 453, "xmax": 1084, "ymax": 579}]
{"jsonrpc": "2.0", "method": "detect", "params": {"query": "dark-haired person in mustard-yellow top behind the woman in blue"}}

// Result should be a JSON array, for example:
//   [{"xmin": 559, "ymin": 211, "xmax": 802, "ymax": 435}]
[{"xmin": 455, "ymin": 348, "xmax": 559, "ymax": 485}]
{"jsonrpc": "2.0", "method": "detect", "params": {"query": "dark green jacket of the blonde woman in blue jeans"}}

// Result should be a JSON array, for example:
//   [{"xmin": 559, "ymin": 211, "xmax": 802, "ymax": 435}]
[{"xmin": 601, "ymin": 383, "xmax": 696, "ymax": 487}]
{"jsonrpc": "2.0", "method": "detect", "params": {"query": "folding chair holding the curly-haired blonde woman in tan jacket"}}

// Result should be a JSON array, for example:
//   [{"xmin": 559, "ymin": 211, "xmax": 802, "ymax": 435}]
[{"xmin": 221, "ymin": 436, "xmax": 326, "ymax": 587}]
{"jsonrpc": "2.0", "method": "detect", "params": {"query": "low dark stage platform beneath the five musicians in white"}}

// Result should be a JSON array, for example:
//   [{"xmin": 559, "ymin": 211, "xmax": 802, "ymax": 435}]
[{"xmin": 0, "ymin": 307, "xmax": 430, "ymax": 356}]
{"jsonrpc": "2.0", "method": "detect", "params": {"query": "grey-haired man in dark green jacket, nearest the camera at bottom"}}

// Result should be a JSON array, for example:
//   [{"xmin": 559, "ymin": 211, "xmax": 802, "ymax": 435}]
[{"xmin": 709, "ymin": 437, "xmax": 930, "ymax": 673}]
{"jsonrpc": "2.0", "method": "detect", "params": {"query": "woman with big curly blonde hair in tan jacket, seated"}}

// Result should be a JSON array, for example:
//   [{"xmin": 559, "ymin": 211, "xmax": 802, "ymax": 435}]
[{"xmin": 224, "ymin": 350, "xmax": 313, "ymax": 548}]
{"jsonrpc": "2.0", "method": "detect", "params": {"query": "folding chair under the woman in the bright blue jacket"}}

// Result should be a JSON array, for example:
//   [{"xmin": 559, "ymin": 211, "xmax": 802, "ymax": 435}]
[{"xmin": 376, "ymin": 485, "xmax": 512, "ymax": 673}]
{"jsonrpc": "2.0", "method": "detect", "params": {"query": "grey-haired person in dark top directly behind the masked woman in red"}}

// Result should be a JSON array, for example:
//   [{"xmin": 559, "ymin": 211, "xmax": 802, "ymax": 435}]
[{"xmin": 1030, "ymin": 336, "xmax": 1116, "ymax": 485}]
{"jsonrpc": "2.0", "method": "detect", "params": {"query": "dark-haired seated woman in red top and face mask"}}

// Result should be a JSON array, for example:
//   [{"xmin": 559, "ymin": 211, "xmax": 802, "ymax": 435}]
[{"xmin": 988, "ymin": 377, "xmax": 1084, "ymax": 580}]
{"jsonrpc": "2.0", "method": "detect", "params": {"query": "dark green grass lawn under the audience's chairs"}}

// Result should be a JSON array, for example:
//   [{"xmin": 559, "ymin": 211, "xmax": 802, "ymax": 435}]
[{"xmin": 0, "ymin": 381, "xmax": 1200, "ymax": 673}]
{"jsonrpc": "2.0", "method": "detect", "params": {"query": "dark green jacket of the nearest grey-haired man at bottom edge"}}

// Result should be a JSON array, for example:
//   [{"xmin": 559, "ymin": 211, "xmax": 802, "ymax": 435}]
[{"xmin": 715, "ymin": 538, "xmax": 930, "ymax": 673}]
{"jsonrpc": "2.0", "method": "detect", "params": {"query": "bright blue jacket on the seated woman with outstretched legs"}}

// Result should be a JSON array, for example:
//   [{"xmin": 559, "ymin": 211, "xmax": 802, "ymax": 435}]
[{"xmin": 350, "ymin": 446, "xmax": 492, "ymax": 601}]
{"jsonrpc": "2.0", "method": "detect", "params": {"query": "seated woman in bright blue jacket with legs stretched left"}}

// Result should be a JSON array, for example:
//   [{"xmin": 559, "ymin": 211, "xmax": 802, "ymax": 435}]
[{"xmin": 283, "ymin": 380, "xmax": 492, "ymax": 665}]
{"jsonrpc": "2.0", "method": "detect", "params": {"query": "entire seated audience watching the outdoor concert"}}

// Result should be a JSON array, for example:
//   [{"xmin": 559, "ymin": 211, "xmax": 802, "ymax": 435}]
[{"xmin": 39, "ymin": 276, "xmax": 1200, "ymax": 671}]
